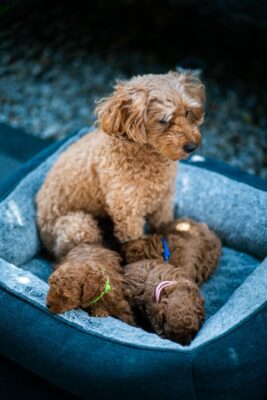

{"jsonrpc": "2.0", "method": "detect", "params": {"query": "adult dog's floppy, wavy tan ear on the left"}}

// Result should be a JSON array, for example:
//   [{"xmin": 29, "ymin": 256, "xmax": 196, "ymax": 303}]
[{"xmin": 96, "ymin": 82, "xmax": 147, "ymax": 144}]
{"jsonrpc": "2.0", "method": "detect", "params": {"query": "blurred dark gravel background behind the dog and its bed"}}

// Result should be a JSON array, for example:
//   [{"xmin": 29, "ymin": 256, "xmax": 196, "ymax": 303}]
[{"xmin": 0, "ymin": 0, "xmax": 267, "ymax": 178}]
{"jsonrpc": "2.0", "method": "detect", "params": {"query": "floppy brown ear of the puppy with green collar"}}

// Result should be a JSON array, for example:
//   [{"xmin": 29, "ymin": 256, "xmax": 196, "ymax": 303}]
[{"xmin": 81, "ymin": 273, "xmax": 106, "ymax": 308}]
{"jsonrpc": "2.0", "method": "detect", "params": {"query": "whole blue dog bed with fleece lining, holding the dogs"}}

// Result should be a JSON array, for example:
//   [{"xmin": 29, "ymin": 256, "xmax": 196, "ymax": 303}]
[{"xmin": 0, "ymin": 129, "xmax": 267, "ymax": 400}]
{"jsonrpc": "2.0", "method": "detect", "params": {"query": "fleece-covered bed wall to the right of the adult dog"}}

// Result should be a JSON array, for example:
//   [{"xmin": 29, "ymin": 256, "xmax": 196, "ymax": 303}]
[{"xmin": 176, "ymin": 159, "xmax": 267, "ymax": 258}]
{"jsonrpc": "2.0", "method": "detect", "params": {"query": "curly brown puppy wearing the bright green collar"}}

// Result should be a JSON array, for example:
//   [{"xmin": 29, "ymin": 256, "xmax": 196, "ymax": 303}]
[{"xmin": 47, "ymin": 244, "xmax": 135, "ymax": 325}]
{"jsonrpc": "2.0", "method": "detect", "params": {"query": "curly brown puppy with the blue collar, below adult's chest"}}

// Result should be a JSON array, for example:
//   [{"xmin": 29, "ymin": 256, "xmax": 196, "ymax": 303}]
[{"xmin": 122, "ymin": 218, "xmax": 221, "ymax": 284}]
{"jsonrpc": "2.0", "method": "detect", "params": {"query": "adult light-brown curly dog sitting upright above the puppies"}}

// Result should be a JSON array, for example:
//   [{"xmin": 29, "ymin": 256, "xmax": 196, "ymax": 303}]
[{"xmin": 36, "ymin": 71, "xmax": 205, "ymax": 257}]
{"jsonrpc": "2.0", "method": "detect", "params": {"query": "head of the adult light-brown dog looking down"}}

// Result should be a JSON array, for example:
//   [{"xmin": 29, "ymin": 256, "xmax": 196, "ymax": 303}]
[{"xmin": 96, "ymin": 71, "xmax": 205, "ymax": 160}]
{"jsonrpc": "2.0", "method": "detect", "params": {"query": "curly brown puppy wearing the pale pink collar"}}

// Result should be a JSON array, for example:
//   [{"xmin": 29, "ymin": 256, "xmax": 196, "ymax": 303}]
[{"xmin": 125, "ymin": 260, "xmax": 204, "ymax": 345}]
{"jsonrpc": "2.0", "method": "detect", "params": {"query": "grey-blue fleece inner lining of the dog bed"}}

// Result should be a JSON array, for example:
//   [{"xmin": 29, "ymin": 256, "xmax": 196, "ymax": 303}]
[{"xmin": 0, "ymin": 129, "xmax": 267, "ymax": 351}]
